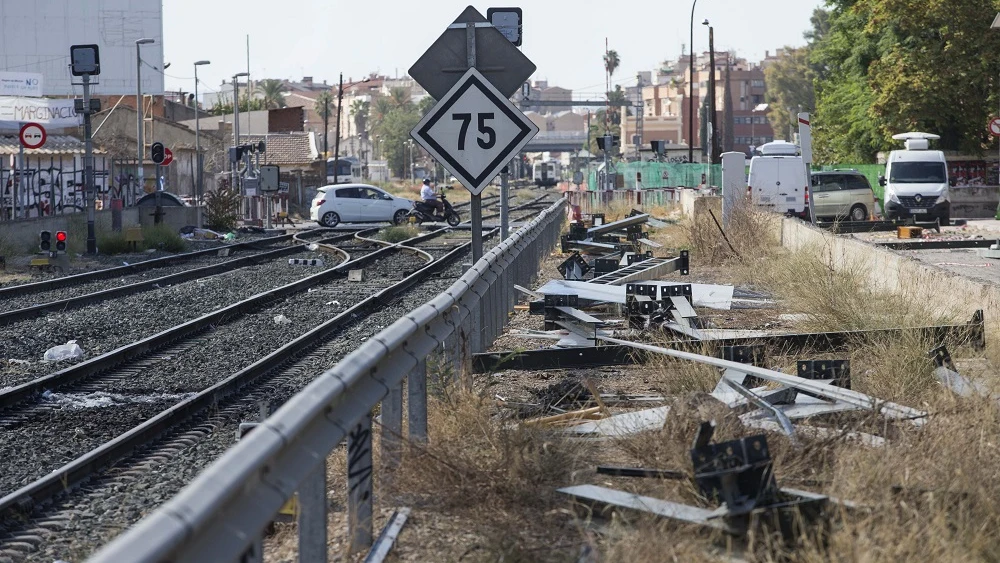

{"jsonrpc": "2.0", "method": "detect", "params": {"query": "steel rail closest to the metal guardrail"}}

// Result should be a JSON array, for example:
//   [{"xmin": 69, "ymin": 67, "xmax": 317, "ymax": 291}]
[{"xmin": 0, "ymin": 230, "xmax": 476, "ymax": 520}]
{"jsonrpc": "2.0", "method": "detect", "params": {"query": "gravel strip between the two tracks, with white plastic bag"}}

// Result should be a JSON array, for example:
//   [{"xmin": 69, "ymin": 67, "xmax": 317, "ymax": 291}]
[{"xmin": 0, "ymin": 252, "xmax": 335, "ymax": 389}]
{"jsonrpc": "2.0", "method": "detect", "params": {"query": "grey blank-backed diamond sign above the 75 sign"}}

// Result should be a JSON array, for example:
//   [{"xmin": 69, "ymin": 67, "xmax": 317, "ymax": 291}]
[{"xmin": 408, "ymin": 6, "xmax": 535, "ymax": 100}]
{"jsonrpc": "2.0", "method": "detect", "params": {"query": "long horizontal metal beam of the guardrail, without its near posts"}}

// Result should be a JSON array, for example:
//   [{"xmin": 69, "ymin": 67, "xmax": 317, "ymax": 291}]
[{"xmin": 90, "ymin": 199, "xmax": 566, "ymax": 563}]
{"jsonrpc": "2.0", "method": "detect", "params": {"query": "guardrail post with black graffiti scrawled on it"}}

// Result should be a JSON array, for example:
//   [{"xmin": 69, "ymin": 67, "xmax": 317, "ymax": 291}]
[{"xmin": 347, "ymin": 411, "xmax": 374, "ymax": 553}]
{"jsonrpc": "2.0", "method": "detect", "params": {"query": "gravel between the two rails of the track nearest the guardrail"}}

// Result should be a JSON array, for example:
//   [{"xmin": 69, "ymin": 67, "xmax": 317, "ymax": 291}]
[{"xmin": 0, "ymin": 254, "xmax": 424, "ymax": 497}]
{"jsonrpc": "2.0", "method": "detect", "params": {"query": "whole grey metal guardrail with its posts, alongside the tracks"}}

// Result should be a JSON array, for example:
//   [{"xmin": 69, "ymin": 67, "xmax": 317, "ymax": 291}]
[{"xmin": 90, "ymin": 196, "xmax": 566, "ymax": 563}]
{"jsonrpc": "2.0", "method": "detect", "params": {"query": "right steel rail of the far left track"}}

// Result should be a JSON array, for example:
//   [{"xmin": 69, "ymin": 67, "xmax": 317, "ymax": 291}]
[{"xmin": 0, "ymin": 234, "xmax": 364, "ymax": 326}]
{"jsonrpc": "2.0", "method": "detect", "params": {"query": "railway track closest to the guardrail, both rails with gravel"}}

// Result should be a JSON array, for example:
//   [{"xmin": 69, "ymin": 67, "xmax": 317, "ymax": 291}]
[{"xmin": 0, "ymin": 200, "xmax": 552, "ymax": 561}]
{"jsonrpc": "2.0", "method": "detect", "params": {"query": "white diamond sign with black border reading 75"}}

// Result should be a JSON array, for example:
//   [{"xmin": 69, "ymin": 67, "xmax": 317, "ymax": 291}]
[{"xmin": 410, "ymin": 68, "xmax": 538, "ymax": 195}]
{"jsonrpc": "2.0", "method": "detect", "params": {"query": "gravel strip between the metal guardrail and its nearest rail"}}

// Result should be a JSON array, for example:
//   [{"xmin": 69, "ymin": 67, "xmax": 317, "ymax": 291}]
[{"xmin": 17, "ymin": 258, "xmax": 461, "ymax": 563}]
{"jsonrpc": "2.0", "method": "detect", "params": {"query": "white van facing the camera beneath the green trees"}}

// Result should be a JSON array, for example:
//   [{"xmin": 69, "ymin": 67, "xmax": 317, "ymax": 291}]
[{"xmin": 878, "ymin": 132, "xmax": 951, "ymax": 225}]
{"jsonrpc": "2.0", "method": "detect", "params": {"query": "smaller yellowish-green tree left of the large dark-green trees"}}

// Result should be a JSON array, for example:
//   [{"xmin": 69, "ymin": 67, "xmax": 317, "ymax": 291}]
[{"xmin": 764, "ymin": 47, "xmax": 816, "ymax": 141}]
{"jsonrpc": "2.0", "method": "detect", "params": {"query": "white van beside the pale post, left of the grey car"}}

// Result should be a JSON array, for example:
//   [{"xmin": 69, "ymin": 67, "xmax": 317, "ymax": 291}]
[{"xmin": 747, "ymin": 141, "xmax": 809, "ymax": 217}]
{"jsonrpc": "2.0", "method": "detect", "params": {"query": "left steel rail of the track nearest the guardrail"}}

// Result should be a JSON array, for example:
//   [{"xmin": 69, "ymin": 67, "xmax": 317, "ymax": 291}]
[{"xmin": 0, "ymin": 227, "xmax": 454, "ymax": 411}]
